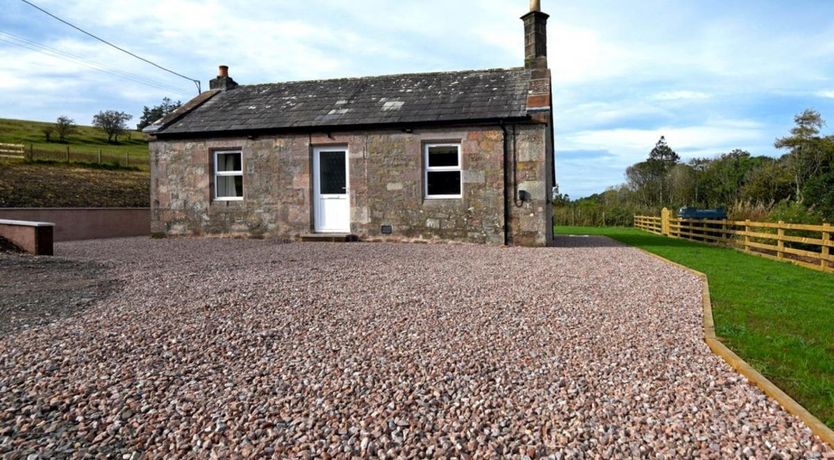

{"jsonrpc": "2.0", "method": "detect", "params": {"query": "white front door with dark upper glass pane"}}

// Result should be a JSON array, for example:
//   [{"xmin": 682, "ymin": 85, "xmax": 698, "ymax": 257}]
[{"xmin": 313, "ymin": 147, "xmax": 350, "ymax": 233}]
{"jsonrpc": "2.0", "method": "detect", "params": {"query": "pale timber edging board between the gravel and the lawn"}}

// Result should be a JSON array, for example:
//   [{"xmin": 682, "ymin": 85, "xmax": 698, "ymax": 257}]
[{"xmin": 629, "ymin": 241, "xmax": 834, "ymax": 448}]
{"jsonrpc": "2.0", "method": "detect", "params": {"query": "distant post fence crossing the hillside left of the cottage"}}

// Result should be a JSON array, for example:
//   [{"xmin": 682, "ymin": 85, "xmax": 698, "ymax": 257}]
[{"xmin": 7, "ymin": 144, "xmax": 149, "ymax": 169}]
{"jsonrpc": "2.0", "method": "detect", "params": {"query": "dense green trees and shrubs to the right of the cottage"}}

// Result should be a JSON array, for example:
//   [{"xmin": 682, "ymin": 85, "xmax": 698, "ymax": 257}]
[{"xmin": 554, "ymin": 109, "xmax": 834, "ymax": 226}]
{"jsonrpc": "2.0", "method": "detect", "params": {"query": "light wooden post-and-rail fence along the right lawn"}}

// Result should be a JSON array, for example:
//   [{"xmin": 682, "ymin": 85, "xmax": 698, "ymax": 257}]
[{"xmin": 634, "ymin": 208, "xmax": 834, "ymax": 273}]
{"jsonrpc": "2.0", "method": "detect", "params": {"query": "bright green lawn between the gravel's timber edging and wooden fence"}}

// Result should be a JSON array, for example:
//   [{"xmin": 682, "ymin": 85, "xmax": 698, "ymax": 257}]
[{"xmin": 556, "ymin": 227, "xmax": 834, "ymax": 428}]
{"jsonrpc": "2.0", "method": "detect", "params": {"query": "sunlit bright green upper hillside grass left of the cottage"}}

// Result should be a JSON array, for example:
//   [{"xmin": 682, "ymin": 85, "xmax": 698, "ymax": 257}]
[{"xmin": 0, "ymin": 119, "xmax": 148, "ymax": 169}]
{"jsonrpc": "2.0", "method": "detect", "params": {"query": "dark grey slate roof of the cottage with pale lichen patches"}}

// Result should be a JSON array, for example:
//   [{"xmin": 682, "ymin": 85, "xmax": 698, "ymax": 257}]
[{"xmin": 148, "ymin": 68, "xmax": 530, "ymax": 135}]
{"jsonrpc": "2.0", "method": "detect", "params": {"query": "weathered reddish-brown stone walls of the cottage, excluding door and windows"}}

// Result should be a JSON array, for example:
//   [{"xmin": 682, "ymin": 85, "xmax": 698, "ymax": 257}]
[{"xmin": 150, "ymin": 125, "xmax": 552, "ymax": 246}]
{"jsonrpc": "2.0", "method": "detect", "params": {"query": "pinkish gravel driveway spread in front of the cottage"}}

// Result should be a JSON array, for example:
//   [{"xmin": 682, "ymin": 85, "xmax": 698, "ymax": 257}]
[{"xmin": 0, "ymin": 238, "xmax": 831, "ymax": 458}]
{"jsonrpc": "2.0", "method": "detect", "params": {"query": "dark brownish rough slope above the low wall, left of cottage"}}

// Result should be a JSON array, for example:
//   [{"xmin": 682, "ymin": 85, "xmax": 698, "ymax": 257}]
[{"xmin": 0, "ymin": 159, "xmax": 150, "ymax": 208}]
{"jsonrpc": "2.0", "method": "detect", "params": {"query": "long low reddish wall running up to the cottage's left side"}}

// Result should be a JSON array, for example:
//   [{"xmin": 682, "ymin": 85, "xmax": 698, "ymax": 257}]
[{"xmin": 0, "ymin": 208, "xmax": 151, "ymax": 241}]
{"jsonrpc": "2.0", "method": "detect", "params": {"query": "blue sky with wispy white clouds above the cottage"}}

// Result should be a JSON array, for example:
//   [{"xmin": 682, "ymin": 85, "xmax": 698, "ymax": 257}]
[{"xmin": 0, "ymin": 0, "xmax": 834, "ymax": 198}]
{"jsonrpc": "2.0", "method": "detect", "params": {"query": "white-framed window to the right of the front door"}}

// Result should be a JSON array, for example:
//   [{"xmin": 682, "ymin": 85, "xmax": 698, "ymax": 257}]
[{"xmin": 423, "ymin": 144, "xmax": 463, "ymax": 199}]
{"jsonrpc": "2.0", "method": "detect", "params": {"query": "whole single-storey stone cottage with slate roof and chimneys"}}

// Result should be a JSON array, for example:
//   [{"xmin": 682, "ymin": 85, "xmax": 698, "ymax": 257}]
[{"xmin": 145, "ymin": 0, "xmax": 554, "ymax": 246}]
